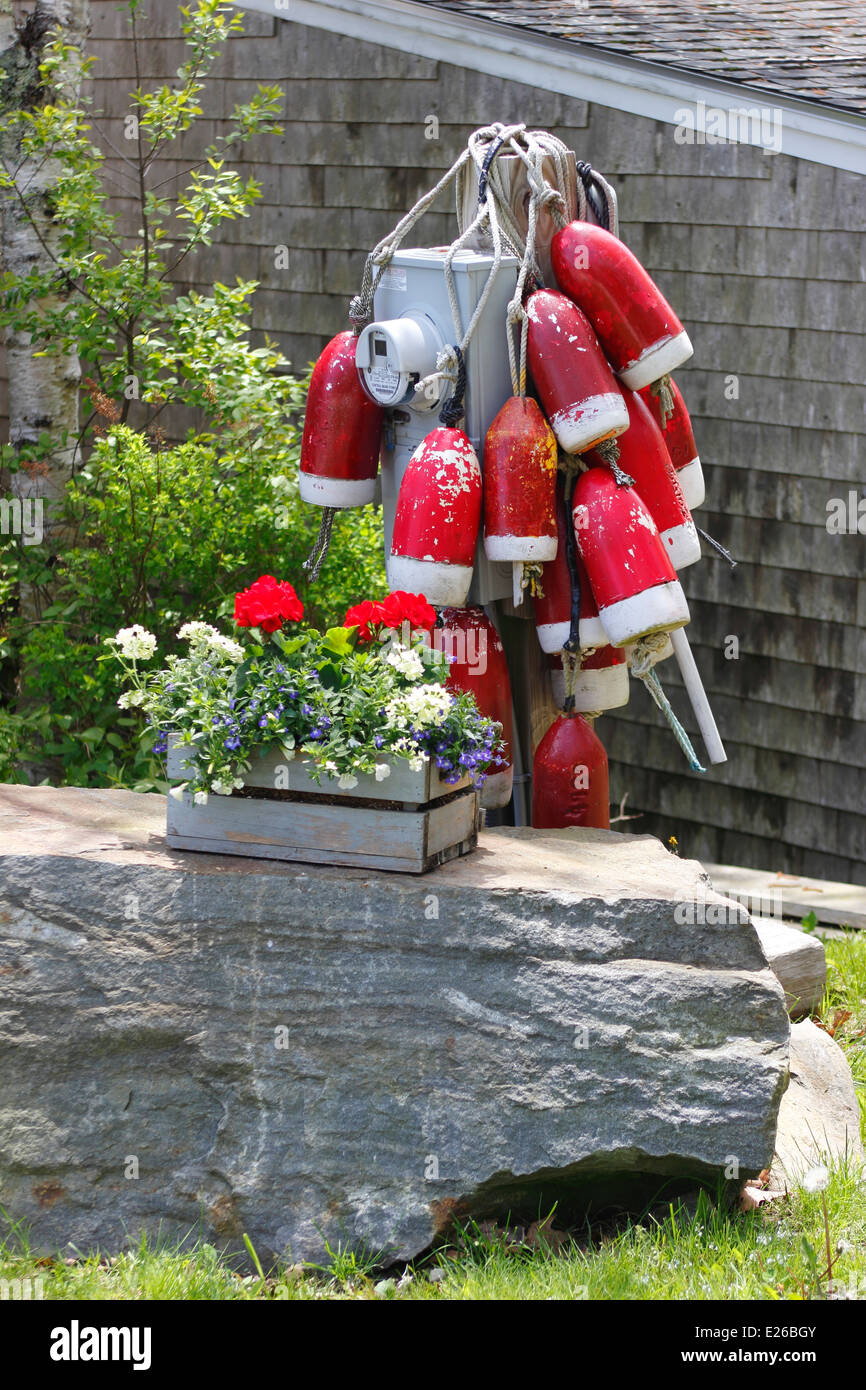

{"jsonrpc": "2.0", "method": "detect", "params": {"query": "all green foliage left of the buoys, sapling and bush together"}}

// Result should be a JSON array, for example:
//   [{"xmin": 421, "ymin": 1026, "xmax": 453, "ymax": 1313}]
[{"xmin": 0, "ymin": 0, "xmax": 385, "ymax": 790}]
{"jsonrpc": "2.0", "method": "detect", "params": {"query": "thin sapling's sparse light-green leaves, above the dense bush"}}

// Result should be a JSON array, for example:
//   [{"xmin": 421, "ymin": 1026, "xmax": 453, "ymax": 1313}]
[{"xmin": 0, "ymin": 0, "xmax": 289, "ymax": 447}]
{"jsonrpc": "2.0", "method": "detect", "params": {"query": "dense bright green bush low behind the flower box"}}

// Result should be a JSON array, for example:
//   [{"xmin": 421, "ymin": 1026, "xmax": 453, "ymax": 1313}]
[{"xmin": 0, "ymin": 417, "xmax": 384, "ymax": 791}]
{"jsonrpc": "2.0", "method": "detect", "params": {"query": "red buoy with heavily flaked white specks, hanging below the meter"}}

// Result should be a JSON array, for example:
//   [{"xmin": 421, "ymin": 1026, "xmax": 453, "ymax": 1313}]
[{"xmin": 388, "ymin": 427, "xmax": 481, "ymax": 607}]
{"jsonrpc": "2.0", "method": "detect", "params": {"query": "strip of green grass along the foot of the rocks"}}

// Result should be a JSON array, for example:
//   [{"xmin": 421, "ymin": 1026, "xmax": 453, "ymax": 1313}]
[{"xmin": 0, "ymin": 933, "xmax": 866, "ymax": 1301}]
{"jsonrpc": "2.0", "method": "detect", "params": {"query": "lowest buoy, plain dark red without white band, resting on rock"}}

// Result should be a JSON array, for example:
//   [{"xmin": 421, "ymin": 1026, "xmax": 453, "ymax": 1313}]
[{"xmin": 532, "ymin": 714, "xmax": 610, "ymax": 830}]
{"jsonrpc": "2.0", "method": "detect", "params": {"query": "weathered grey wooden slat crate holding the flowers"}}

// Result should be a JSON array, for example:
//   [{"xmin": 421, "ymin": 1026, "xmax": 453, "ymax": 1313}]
[{"xmin": 167, "ymin": 741, "xmax": 478, "ymax": 873}]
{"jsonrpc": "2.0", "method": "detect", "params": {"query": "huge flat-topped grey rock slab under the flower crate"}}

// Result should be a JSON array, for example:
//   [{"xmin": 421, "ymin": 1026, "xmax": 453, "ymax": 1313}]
[{"xmin": 0, "ymin": 787, "xmax": 788, "ymax": 1259}]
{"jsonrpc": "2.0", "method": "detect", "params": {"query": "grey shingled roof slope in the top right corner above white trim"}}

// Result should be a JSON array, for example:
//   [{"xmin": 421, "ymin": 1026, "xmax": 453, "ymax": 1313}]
[{"xmin": 418, "ymin": 0, "xmax": 866, "ymax": 111}]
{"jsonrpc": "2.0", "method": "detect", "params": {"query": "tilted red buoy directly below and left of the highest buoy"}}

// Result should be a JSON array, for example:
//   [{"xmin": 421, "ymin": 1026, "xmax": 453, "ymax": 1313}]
[{"xmin": 527, "ymin": 289, "xmax": 628, "ymax": 453}]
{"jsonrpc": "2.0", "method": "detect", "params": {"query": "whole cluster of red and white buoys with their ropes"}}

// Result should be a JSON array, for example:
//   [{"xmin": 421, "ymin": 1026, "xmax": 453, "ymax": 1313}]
[{"xmin": 300, "ymin": 126, "xmax": 724, "ymax": 827}]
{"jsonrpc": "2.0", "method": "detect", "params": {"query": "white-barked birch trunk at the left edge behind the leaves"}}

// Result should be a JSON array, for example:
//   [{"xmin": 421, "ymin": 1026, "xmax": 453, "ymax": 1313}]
[{"xmin": 0, "ymin": 0, "xmax": 89, "ymax": 575}]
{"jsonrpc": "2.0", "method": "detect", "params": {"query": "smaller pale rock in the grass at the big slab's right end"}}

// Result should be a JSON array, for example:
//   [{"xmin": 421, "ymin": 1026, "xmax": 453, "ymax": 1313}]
[{"xmin": 770, "ymin": 1019, "xmax": 863, "ymax": 1191}]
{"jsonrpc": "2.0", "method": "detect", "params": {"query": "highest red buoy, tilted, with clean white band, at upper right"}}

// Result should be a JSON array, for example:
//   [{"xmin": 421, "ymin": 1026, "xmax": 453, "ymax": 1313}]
[{"xmin": 550, "ymin": 222, "xmax": 694, "ymax": 391}]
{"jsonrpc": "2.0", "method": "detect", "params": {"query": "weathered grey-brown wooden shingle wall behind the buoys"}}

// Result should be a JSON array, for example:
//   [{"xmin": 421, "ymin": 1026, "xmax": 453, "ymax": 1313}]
[{"xmin": 8, "ymin": 0, "xmax": 866, "ymax": 883}]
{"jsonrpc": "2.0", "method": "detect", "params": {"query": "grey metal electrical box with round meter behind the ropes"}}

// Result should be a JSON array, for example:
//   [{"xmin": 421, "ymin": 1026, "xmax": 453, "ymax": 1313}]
[{"xmin": 356, "ymin": 246, "xmax": 518, "ymax": 605}]
